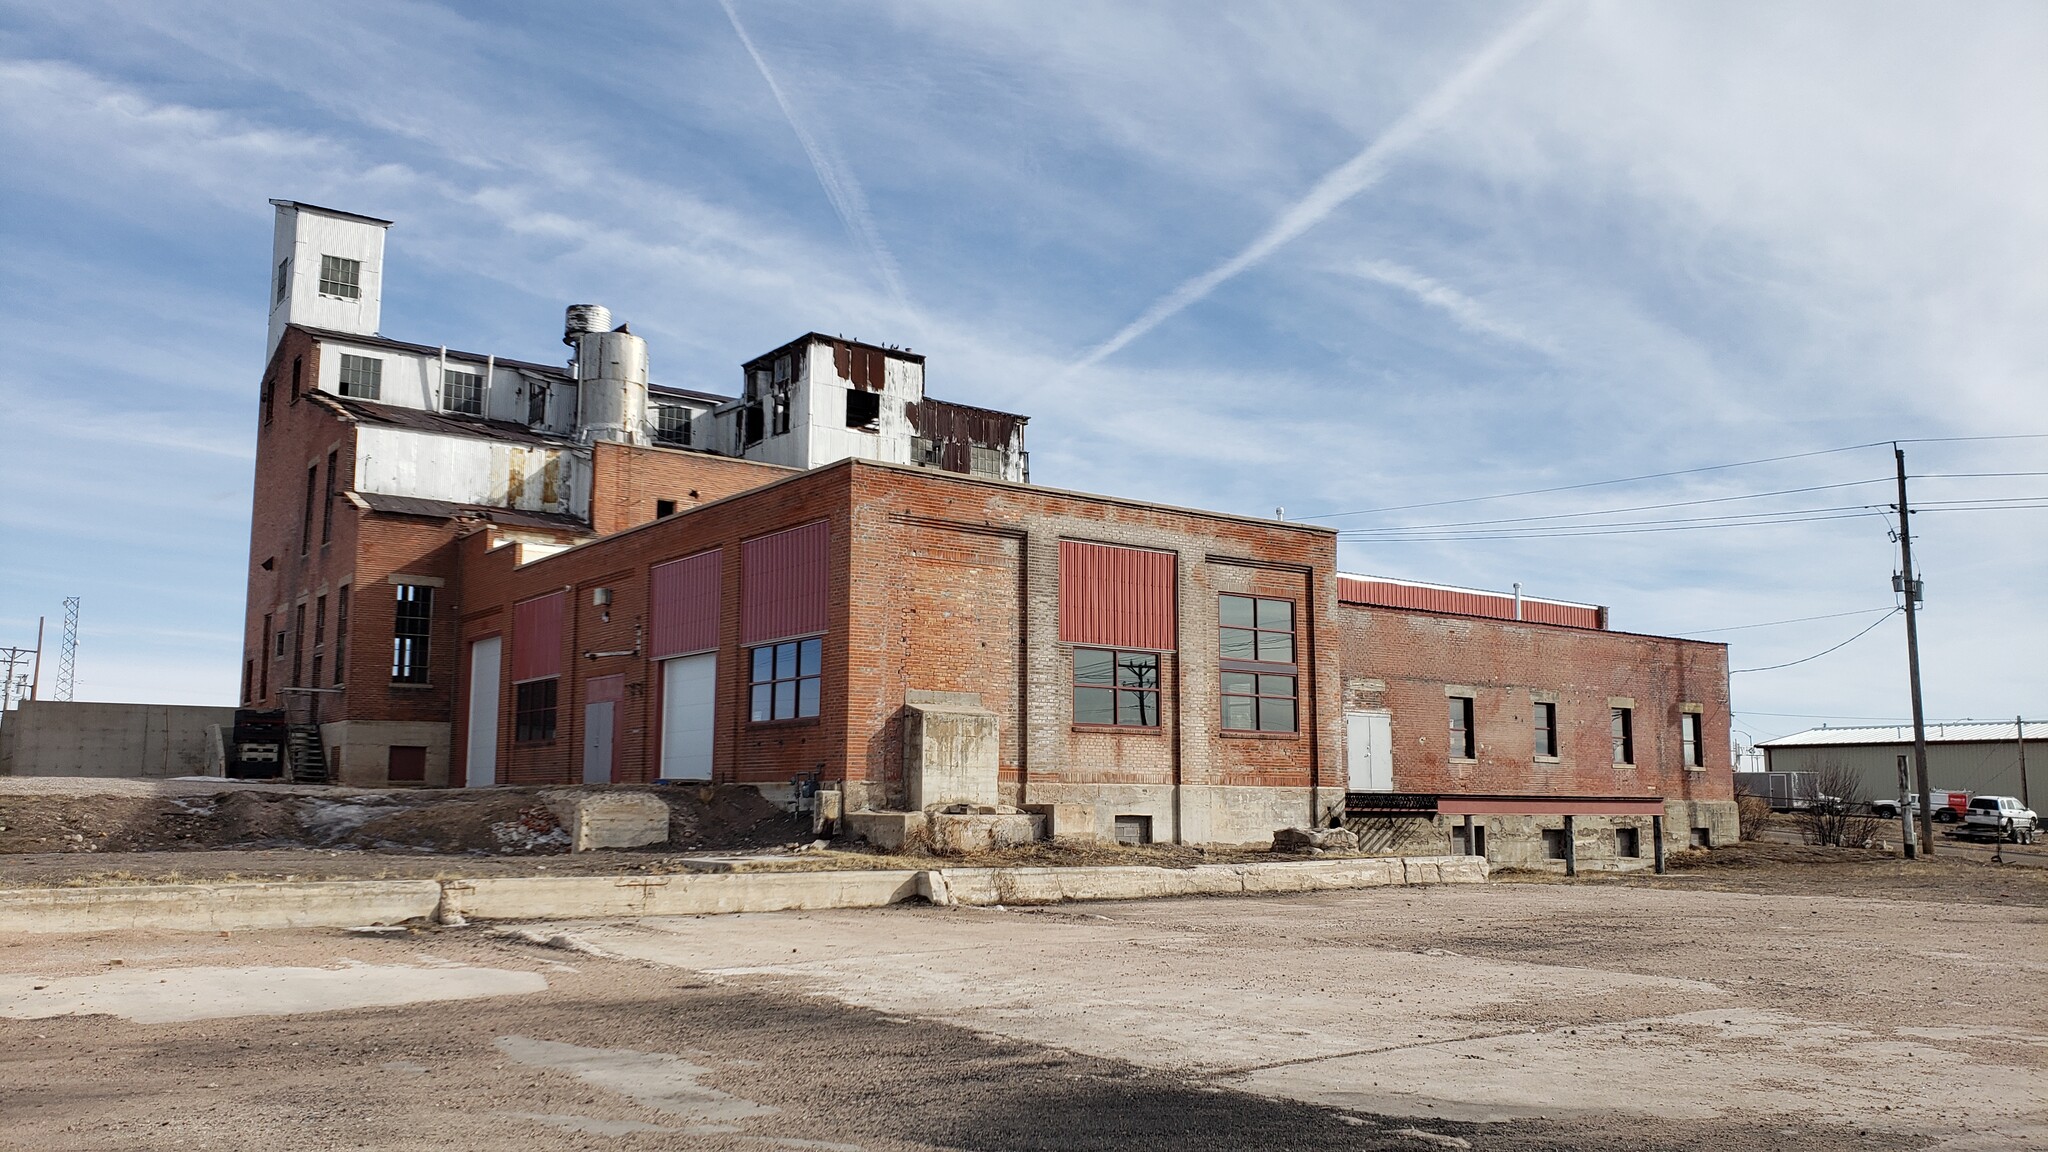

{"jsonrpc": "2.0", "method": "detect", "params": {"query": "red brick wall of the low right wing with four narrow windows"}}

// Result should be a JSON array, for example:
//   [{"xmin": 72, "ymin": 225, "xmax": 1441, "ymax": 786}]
[{"xmin": 1337, "ymin": 605, "xmax": 1735, "ymax": 799}]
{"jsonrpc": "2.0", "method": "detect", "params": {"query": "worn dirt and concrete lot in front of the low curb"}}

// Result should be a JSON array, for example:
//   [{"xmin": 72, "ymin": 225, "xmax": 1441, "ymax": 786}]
[{"xmin": 0, "ymin": 849, "xmax": 2048, "ymax": 1152}]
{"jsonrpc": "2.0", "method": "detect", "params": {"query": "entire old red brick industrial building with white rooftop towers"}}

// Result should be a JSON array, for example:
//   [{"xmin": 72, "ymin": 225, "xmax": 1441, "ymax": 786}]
[{"xmin": 244, "ymin": 203, "xmax": 1733, "ymax": 861}]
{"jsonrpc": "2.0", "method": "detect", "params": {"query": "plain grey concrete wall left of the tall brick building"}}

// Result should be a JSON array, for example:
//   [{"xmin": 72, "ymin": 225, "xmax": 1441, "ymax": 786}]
[{"xmin": 0, "ymin": 701, "xmax": 236, "ymax": 777}]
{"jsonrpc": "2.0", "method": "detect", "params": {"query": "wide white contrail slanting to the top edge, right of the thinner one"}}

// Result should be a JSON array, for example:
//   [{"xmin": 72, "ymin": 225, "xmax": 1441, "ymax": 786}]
[{"xmin": 1073, "ymin": 0, "xmax": 1563, "ymax": 371}]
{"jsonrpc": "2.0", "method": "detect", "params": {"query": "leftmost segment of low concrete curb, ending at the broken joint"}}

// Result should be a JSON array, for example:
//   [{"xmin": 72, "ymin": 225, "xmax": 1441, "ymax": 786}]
[{"xmin": 0, "ymin": 879, "xmax": 440, "ymax": 937}]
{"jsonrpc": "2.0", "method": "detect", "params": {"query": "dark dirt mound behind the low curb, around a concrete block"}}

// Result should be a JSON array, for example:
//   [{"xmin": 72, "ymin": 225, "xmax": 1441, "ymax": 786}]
[{"xmin": 0, "ymin": 783, "xmax": 809, "ymax": 855}]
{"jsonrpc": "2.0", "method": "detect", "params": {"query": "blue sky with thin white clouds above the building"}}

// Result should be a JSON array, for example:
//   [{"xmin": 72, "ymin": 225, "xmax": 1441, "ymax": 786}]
[{"xmin": 0, "ymin": 0, "xmax": 2048, "ymax": 738}]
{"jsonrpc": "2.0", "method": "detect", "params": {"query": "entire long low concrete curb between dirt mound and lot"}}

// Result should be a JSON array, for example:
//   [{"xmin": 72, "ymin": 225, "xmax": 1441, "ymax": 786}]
[{"xmin": 0, "ymin": 857, "xmax": 1487, "ymax": 937}]
